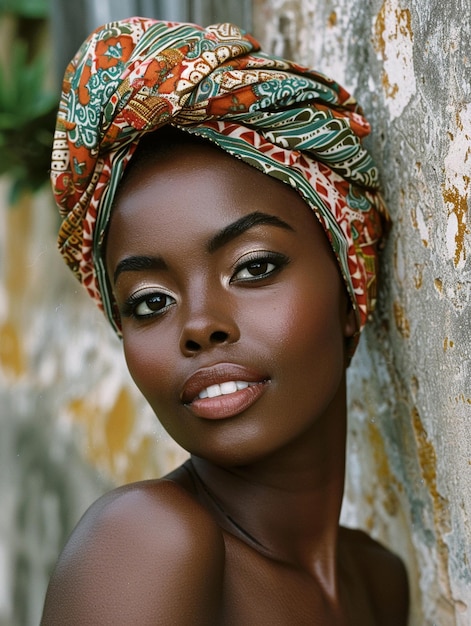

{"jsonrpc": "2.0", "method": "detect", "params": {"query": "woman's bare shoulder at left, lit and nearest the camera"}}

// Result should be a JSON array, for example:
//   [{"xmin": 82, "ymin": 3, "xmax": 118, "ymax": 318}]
[{"xmin": 41, "ymin": 480, "xmax": 224, "ymax": 626}]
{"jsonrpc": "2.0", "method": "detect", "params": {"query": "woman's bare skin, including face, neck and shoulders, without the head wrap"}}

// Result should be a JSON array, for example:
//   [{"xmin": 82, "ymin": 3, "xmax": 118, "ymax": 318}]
[{"xmin": 42, "ymin": 142, "xmax": 408, "ymax": 626}]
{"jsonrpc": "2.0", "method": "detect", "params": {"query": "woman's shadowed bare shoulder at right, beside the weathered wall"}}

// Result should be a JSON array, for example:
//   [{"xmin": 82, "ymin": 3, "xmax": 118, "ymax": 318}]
[{"xmin": 341, "ymin": 528, "xmax": 409, "ymax": 626}]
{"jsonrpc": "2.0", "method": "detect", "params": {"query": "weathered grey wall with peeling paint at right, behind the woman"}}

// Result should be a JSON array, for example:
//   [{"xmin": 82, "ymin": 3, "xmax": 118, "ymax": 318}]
[{"xmin": 255, "ymin": 0, "xmax": 471, "ymax": 626}]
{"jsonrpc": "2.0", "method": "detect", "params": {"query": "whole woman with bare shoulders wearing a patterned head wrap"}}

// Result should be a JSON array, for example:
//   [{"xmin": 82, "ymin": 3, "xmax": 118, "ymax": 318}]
[{"xmin": 42, "ymin": 18, "xmax": 408, "ymax": 626}]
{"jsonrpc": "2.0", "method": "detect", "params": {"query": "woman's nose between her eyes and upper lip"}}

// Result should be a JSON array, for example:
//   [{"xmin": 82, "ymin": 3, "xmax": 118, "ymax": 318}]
[{"xmin": 180, "ymin": 298, "xmax": 240, "ymax": 356}]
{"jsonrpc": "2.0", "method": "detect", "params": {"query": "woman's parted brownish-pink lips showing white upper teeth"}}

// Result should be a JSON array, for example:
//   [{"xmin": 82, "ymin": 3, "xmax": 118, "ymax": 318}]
[{"xmin": 181, "ymin": 363, "xmax": 269, "ymax": 419}]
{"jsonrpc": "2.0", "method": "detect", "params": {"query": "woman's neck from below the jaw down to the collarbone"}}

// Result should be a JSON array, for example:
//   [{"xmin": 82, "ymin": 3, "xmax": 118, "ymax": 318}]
[{"xmin": 188, "ymin": 400, "xmax": 346, "ymax": 595}]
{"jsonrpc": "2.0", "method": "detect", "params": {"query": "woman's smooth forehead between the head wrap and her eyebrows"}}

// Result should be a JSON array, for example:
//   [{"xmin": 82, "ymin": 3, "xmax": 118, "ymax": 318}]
[{"xmin": 107, "ymin": 138, "xmax": 332, "ymax": 256}]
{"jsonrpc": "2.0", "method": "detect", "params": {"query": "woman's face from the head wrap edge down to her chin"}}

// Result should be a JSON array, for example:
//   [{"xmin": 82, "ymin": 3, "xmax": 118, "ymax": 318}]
[{"xmin": 107, "ymin": 139, "xmax": 355, "ymax": 465}]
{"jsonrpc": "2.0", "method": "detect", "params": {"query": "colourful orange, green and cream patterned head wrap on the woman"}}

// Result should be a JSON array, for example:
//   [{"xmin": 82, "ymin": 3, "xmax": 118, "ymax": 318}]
[{"xmin": 51, "ymin": 17, "xmax": 388, "ymax": 352}]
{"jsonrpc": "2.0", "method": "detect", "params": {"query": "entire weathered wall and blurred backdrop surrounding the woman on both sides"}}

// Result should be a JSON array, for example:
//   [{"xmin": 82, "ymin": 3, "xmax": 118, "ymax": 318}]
[{"xmin": 0, "ymin": 0, "xmax": 471, "ymax": 626}]
